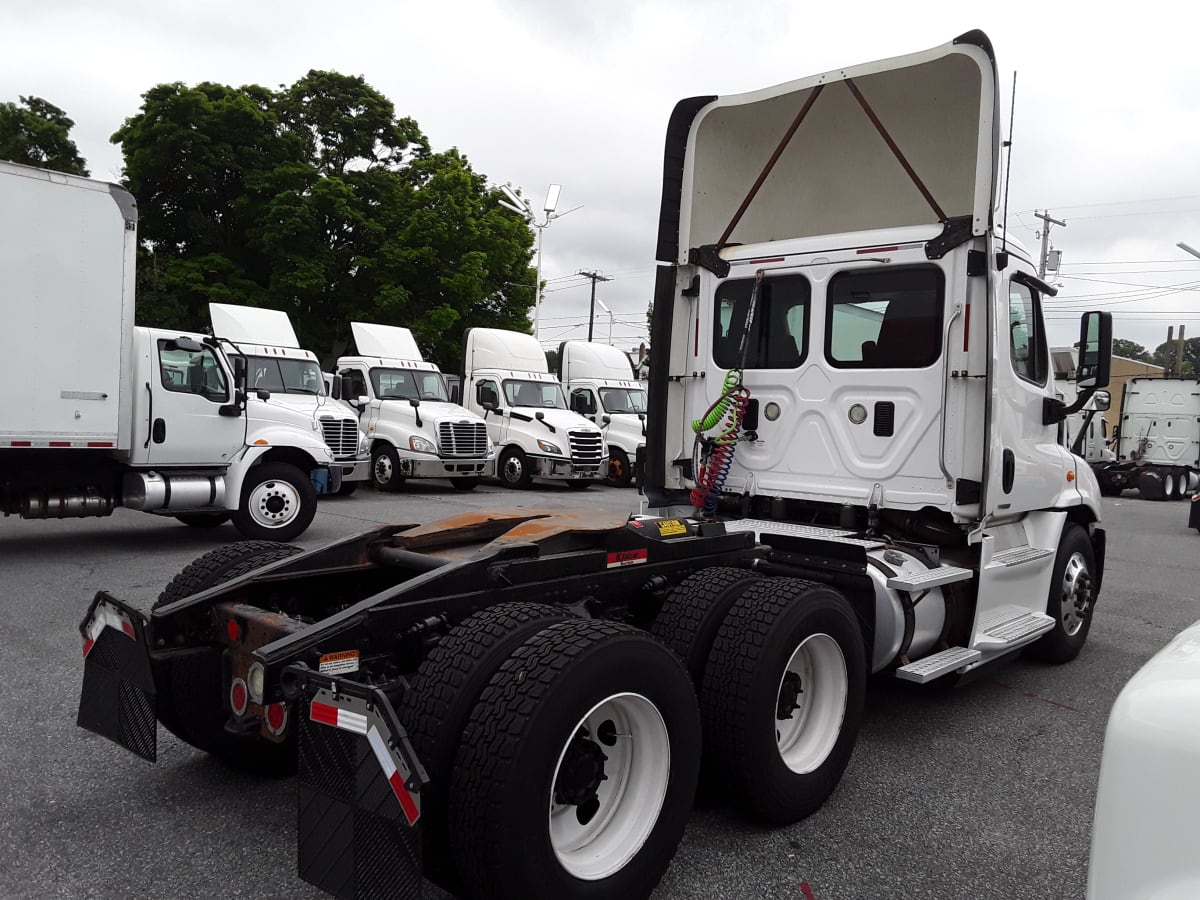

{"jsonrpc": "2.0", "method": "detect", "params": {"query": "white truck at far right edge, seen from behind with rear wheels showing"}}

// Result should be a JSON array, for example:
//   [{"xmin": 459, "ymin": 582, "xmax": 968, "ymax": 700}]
[{"xmin": 1096, "ymin": 377, "xmax": 1200, "ymax": 500}]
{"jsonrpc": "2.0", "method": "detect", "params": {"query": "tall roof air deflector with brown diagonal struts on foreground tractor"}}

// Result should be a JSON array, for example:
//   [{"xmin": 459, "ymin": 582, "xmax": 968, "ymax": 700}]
[{"xmin": 658, "ymin": 31, "xmax": 1000, "ymax": 271}]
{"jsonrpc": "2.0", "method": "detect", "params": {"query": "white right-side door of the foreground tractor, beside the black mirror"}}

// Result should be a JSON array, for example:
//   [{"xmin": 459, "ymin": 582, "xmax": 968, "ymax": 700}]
[{"xmin": 984, "ymin": 272, "xmax": 1074, "ymax": 516}]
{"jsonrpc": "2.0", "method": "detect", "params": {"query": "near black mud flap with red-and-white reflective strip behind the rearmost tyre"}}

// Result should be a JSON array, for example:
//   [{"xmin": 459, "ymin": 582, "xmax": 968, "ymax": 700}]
[{"xmin": 286, "ymin": 666, "xmax": 428, "ymax": 900}]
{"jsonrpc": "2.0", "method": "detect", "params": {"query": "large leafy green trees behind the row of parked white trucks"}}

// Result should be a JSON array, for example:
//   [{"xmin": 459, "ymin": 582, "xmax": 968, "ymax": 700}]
[{"xmin": 113, "ymin": 71, "xmax": 535, "ymax": 372}]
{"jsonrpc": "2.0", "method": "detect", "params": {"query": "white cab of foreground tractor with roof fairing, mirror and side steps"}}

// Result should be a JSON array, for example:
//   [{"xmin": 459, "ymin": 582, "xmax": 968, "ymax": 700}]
[{"xmin": 644, "ymin": 32, "xmax": 1111, "ymax": 682}]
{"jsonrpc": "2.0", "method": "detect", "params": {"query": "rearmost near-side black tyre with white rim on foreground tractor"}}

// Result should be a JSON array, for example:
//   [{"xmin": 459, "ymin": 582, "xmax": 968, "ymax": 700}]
[{"xmin": 450, "ymin": 619, "xmax": 700, "ymax": 900}]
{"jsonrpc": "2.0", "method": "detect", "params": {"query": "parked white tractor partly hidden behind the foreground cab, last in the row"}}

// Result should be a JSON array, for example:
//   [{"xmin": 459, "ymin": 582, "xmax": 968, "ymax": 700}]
[{"xmin": 558, "ymin": 341, "xmax": 646, "ymax": 487}]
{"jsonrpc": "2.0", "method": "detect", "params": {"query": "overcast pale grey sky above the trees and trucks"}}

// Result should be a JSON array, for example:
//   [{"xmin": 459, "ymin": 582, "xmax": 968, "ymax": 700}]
[{"xmin": 0, "ymin": 0, "xmax": 1200, "ymax": 360}]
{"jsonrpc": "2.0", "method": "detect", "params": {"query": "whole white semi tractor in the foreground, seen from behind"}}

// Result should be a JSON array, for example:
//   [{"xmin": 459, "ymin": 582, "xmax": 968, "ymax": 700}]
[{"xmin": 79, "ymin": 31, "xmax": 1111, "ymax": 900}]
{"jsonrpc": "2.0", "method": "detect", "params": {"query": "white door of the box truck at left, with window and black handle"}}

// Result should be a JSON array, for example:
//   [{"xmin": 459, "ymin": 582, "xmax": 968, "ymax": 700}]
[{"xmin": 138, "ymin": 336, "xmax": 246, "ymax": 466}]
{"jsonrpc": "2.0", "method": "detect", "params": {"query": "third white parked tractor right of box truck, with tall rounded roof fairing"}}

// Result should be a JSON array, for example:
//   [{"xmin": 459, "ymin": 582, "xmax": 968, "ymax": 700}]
[{"xmin": 463, "ymin": 328, "xmax": 608, "ymax": 490}]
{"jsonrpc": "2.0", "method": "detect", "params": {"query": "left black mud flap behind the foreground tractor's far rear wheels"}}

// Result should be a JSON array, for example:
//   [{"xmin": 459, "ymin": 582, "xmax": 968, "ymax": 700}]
[{"xmin": 76, "ymin": 590, "xmax": 158, "ymax": 762}]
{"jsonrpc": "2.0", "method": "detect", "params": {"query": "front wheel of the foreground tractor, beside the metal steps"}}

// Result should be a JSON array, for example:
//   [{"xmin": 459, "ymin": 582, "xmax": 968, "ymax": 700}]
[{"xmin": 1030, "ymin": 523, "xmax": 1099, "ymax": 662}]
